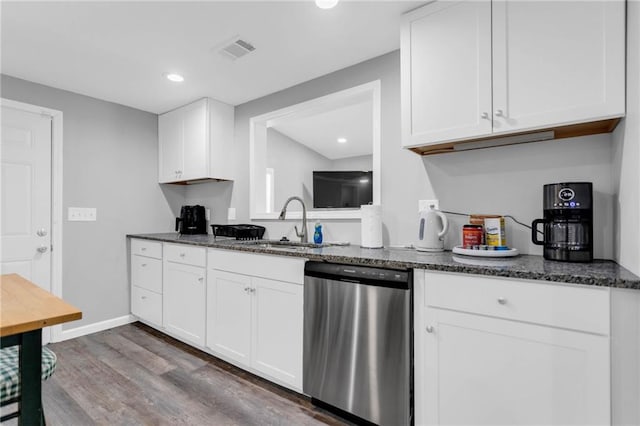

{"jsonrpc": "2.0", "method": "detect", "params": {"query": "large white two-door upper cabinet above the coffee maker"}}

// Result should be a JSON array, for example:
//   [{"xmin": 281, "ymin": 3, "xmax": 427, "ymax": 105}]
[{"xmin": 401, "ymin": 0, "xmax": 625, "ymax": 149}]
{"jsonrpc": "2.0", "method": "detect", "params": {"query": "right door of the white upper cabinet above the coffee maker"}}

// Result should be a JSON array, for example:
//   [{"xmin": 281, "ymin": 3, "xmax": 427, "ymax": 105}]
[{"xmin": 490, "ymin": 0, "xmax": 625, "ymax": 132}]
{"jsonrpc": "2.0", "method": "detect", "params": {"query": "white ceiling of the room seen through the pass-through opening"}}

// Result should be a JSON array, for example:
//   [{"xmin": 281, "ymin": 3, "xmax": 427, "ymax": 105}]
[{"xmin": 273, "ymin": 100, "xmax": 373, "ymax": 160}]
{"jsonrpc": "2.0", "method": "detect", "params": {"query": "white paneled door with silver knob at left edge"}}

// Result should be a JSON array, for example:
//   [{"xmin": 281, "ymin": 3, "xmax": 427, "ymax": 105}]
[{"xmin": 0, "ymin": 106, "xmax": 51, "ymax": 343}]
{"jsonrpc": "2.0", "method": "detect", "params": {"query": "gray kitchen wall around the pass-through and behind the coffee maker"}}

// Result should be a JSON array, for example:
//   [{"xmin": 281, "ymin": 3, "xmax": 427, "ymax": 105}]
[{"xmin": 185, "ymin": 51, "xmax": 620, "ymax": 258}]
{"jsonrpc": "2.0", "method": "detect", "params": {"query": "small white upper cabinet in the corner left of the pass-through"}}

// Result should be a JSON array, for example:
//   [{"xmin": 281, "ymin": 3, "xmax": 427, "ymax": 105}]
[{"xmin": 158, "ymin": 98, "xmax": 234, "ymax": 183}]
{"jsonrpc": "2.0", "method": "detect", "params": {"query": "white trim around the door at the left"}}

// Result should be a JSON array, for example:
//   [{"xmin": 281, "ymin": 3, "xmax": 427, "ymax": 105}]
[{"xmin": 0, "ymin": 98, "xmax": 64, "ymax": 342}]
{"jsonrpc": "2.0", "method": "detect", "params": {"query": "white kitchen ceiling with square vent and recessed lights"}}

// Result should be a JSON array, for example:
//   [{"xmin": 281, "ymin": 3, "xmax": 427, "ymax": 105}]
[{"xmin": 0, "ymin": 0, "xmax": 425, "ymax": 113}]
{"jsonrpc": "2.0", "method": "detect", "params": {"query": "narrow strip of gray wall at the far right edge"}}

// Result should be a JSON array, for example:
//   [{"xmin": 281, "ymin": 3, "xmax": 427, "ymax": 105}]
[{"xmin": 613, "ymin": 1, "xmax": 640, "ymax": 275}]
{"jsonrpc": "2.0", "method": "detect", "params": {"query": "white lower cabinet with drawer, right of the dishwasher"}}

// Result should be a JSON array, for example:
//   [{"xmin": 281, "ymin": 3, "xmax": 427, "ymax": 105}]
[{"xmin": 414, "ymin": 271, "xmax": 611, "ymax": 425}]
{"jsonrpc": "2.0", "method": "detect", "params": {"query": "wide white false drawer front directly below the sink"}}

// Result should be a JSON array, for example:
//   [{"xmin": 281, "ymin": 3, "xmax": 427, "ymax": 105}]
[{"xmin": 208, "ymin": 249, "xmax": 306, "ymax": 284}]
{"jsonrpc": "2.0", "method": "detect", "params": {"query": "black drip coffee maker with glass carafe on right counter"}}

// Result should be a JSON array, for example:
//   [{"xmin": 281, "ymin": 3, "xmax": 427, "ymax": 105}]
[{"xmin": 531, "ymin": 182, "xmax": 593, "ymax": 262}]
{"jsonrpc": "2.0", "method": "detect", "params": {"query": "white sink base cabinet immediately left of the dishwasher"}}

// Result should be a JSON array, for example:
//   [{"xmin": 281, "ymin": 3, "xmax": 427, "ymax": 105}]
[{"xmin": 206, "ymin": 249, "xmax": 305, "ymax": 391}]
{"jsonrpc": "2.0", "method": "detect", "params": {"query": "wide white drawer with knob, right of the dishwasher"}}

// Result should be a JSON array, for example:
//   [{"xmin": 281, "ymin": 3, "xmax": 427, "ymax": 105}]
[{"xmin": 424, "ymin": 272, "xmax": 609, "ymax": 335}]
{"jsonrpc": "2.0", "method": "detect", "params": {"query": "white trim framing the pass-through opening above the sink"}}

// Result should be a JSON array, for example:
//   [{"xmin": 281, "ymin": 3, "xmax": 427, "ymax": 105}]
[{"xmin": 249, "ymin": 80, "xmax": 382, "ymax": 219}]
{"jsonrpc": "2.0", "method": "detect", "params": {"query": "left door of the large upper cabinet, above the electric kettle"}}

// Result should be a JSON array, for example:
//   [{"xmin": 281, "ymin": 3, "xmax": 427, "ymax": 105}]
[{"xmin": 401, "ymin": 1, "xmax": 492, "ymax": 147}]
